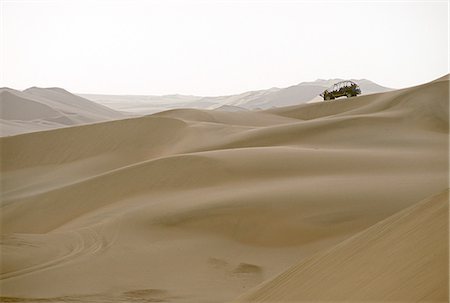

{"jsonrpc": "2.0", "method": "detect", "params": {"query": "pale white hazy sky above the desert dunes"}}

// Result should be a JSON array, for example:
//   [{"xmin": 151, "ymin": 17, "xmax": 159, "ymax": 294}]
[{"xmin": 0, "ymin": 0, "xmax": 449, "ymax": 95}]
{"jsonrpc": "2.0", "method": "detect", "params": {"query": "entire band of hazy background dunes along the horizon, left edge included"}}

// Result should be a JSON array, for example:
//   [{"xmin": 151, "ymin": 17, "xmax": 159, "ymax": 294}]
[{"xmin": 0, "ymin": 79, "xmax": 391, "ymax": 136}]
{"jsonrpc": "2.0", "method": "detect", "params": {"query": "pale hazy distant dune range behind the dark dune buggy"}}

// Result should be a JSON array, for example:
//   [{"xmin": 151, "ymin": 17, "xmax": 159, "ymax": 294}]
[{"xmin": 80, "ymin": 79, "xmax": 392, "ymax": 114}]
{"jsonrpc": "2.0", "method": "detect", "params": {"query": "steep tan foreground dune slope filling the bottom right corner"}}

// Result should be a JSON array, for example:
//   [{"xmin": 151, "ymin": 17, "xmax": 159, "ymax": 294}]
[{"xmin": 235, "ymin": 191, "xmax": 449, "ymax": 302}]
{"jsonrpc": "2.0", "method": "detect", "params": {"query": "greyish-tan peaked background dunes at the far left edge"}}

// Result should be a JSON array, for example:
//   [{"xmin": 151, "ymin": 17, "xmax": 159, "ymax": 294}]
[{"xmin": 0, "ymin": 87, "xmax": 125, "ymax": 136}]
